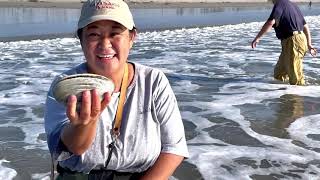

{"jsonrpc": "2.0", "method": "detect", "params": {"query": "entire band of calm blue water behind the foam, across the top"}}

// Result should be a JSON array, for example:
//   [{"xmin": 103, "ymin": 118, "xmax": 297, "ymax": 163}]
[{"xmin": 0, "ymin": 5, "xmax": 320, "ymax": 41}]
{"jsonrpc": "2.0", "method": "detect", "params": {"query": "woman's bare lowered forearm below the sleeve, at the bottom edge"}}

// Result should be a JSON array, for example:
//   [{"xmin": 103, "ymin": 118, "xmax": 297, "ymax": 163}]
[{"xmin": 140, "ymin": 153, "xmax": 184, "ymax": 180}]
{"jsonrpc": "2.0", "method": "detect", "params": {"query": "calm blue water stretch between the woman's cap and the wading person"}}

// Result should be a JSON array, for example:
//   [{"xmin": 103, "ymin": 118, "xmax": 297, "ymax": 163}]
[{"xmin": 132, "ymin": 7, "xmax": 271, "ymax": 31}]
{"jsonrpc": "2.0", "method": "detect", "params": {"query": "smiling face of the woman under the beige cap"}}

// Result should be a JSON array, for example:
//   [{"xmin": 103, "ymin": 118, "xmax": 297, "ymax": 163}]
[{"xmin": 81, "ymin": 20, "xmax": 136, "ymax": 77}]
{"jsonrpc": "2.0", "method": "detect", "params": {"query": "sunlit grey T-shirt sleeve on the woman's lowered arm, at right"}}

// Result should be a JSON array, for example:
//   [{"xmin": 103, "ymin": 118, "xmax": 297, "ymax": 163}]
[{"xmin": 154, "ymin": 72, "xmax": 189, "ymax": 157}]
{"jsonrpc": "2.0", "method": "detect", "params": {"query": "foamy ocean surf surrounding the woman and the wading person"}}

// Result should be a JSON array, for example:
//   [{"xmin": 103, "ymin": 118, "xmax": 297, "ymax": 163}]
[{"xmin": 0, "ymin": 5, "xmax": 320, "ymax": 180}]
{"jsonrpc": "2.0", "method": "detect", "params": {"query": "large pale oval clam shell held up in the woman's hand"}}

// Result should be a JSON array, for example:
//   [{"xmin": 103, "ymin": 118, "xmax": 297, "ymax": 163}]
[{"xmin": 53, "ymin": 74, "xmax": 115, "ymax": 107}]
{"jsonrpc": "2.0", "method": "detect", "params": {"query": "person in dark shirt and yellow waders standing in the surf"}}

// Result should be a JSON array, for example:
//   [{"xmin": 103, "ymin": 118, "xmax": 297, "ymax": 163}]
[{"xmin": 251, "ymin": 0, "xmax": 316, "ymax": 85}]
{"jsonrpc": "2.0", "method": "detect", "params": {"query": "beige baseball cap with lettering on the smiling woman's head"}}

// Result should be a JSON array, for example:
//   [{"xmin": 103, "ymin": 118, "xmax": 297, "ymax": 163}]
[{"xmin": 78, "ymin": 0, "xmax": 135, "ymax": 30}]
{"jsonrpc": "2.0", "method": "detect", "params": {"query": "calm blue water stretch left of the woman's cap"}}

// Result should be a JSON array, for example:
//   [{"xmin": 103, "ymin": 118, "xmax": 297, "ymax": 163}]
[{"xmin": 0, "ymin": 8, "xmax": 79, "ymax": 40}]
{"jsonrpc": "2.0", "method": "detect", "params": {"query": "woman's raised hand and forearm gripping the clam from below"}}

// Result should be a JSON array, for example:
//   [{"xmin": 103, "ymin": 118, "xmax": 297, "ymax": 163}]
[{"xmin": 61, "ymin": 90, "xmax": 111, "ymax": 155}]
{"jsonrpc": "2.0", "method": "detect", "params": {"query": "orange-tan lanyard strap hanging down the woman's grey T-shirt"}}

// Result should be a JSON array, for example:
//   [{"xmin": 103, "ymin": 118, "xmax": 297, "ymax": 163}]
[{"xmin": 105, "ymin": 64, "xmax": 128, "ymax": 168}]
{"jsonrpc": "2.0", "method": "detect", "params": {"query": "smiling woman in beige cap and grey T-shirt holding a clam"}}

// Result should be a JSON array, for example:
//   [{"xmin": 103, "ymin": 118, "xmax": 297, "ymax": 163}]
[{"xmin": 45, "ymin": 0, "xmax": 188, "ymax": 180}]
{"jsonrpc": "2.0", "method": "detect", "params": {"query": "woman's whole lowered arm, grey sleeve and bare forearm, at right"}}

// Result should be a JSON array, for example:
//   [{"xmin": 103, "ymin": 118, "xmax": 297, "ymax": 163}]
[{"xmin": 140, "ymin": 72, "xmax": 189, "ymax": 180}]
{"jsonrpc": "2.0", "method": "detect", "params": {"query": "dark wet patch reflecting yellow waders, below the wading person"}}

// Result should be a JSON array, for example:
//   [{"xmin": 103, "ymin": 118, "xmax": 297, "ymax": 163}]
[{"xmin": 248, "ymin": 94, "xmax": 304, "ymax": 139}]
